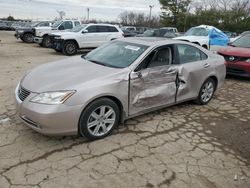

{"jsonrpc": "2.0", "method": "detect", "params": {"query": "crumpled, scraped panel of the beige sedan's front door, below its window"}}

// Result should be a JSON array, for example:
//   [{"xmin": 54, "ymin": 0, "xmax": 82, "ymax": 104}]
[{"xmin": 129, "ymin": 65, "xmax": 178, "ymax": 115}]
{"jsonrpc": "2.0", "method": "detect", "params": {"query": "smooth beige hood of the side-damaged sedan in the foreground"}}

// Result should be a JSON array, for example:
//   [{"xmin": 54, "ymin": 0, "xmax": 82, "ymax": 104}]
[{"xmin": 21, "ymin": 56, "xmax": 123, "ymax": 93}]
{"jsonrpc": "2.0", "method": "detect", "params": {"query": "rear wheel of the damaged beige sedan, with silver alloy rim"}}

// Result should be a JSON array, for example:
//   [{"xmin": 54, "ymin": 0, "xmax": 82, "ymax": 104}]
[{"xmin": 195, "ymin": 78, "xmax": 216, "ymax": 105}]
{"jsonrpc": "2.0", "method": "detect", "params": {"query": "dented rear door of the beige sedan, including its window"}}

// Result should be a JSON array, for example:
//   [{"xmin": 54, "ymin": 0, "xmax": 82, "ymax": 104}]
[{"xmin": 176, "ymin": 44, "xmax": 213, "ymax": 102}]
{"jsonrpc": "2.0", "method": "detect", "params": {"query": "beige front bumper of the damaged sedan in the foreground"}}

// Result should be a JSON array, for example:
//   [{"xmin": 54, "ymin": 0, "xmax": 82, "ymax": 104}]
[{"xmin": 15, "ymin": 86, "xmax": 82, "ymax": 136}]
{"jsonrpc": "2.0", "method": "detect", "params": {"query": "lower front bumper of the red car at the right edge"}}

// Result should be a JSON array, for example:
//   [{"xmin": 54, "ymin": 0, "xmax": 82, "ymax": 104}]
[{"xmin": 226, "ymin": 62, "xmax": 250, "ymax": 77}]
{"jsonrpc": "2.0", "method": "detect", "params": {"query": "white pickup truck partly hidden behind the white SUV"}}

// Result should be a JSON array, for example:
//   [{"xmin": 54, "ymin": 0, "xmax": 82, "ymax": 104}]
[{"xmin": 34, "ymin": 20, "xmax": 80, "ymax": 48}]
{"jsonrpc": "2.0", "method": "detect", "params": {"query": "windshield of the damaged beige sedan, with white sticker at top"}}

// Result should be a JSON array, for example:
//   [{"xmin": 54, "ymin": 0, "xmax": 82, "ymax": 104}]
[{"xmin": 83, "ymin": 41, "xmax": 148, "ymax": 68}]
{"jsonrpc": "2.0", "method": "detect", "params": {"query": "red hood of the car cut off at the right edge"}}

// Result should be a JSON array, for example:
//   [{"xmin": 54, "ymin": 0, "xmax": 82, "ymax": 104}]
[{"xmin": 218, "ymin": 47, "xmax": 250, "ymax": 57}]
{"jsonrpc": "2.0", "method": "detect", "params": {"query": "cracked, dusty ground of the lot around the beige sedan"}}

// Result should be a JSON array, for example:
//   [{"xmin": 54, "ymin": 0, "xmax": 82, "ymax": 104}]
[{"xmin": 0, "ymin": 31, "xmax": 250, "ymax": 188}]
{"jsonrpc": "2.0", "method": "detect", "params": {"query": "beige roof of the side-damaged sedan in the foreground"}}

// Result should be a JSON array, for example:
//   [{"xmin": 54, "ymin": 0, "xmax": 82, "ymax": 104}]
[{"xmin": 118, "ymin": 37, "xmax": 186, "ymax": 46}]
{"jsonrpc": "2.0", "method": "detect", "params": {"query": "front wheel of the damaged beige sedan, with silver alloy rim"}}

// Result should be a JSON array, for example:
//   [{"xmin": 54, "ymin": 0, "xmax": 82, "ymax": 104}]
[{"xmin": 79, "ymin": 98, "xmax": 120, "ymax": 140}]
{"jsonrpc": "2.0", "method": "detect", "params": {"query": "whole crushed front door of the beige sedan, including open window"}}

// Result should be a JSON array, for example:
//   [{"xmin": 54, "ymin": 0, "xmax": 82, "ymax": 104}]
[{"xmin": 129, "ymin": 46, "xmax": 177, "ymax": 115}]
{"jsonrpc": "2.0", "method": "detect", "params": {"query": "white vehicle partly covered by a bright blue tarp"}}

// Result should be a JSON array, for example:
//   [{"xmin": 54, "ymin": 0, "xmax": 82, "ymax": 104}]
[{"xmin": 174, "ymin": 25, "xmax": 229, "ymax": 49}]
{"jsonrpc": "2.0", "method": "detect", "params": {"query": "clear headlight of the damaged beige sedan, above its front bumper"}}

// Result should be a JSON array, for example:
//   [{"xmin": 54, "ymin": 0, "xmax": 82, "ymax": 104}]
[{"xmin": 30, "ymin": 91, "xmax": 76, "ymax": 104}]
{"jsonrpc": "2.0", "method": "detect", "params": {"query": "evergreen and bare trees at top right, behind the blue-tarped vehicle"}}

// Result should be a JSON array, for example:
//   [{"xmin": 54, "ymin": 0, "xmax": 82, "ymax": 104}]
[{"xmin": 159, "ymin": 0, "xmax": 250, "ymax": 33}]
